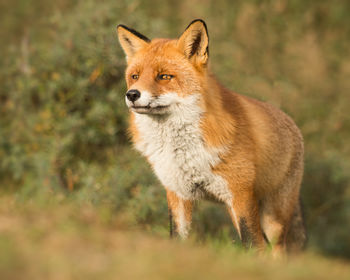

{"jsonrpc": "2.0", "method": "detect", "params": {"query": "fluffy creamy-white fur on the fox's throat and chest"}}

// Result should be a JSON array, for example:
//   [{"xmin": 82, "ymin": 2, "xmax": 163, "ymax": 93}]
[{"xmin": 134, "ymin": 95, "xmax": 231, "ymax": 201}]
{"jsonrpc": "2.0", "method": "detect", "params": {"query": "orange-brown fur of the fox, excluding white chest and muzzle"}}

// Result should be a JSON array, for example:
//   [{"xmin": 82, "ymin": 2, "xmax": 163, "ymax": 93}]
[{"xmin": 118, "ymin": 18, "xmax": 305, "ymax": 251}]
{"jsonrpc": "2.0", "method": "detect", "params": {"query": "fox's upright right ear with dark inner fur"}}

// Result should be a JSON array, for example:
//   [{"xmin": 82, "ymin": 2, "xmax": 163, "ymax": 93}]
[{"xmin": 177, "ymin": 19, "xmax": 209, "ymax": 64}]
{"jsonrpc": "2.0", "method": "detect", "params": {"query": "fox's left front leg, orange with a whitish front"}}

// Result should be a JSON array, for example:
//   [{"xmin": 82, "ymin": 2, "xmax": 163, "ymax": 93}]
[{"xmin": 167, "ymin": 190, "xmax": 192, "ymax": 239}]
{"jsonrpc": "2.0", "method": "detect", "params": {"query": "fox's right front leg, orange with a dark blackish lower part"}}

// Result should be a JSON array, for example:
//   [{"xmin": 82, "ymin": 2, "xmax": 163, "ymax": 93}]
[{"xmin": 227, "ymin": 190, "xmax": 266, "ymax": 250}]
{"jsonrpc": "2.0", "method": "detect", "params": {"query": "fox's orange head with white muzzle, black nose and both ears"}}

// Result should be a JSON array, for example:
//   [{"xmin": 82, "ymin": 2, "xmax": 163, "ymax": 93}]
[{"xmin": 117, "ymin": 19, "xmax": 209, "ymax": 114}]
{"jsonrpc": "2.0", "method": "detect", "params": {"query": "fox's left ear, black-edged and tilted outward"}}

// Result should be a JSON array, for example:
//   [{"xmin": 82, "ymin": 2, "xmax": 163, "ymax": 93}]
[{"xmin": 117, "ymin": 24, "xmax": 151, "ymax": 59}]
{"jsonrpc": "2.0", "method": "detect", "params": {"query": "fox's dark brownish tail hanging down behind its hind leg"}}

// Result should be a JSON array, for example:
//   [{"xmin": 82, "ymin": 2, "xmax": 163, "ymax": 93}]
[{"xmin": 286, "ymin": 198, "xmax": 307, "ymax": 253}]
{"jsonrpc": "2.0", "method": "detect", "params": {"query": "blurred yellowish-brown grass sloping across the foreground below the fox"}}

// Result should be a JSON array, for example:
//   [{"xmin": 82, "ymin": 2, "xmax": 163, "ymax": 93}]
[{"xmin": 0, "ymin": 195, "xmax": 350, "ymax": 280}]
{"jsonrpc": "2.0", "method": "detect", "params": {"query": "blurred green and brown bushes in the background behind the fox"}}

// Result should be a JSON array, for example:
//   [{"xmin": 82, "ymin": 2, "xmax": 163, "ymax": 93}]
[{"xmin": 0, "ymin": 0, "xmax": 350, "ymax": 270}]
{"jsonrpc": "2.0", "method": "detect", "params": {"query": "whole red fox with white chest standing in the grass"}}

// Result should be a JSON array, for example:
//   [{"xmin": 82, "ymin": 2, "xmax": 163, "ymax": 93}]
[{"xmin": 117, "ymin": 19, "xmax": 306, "ymax": 253}]
